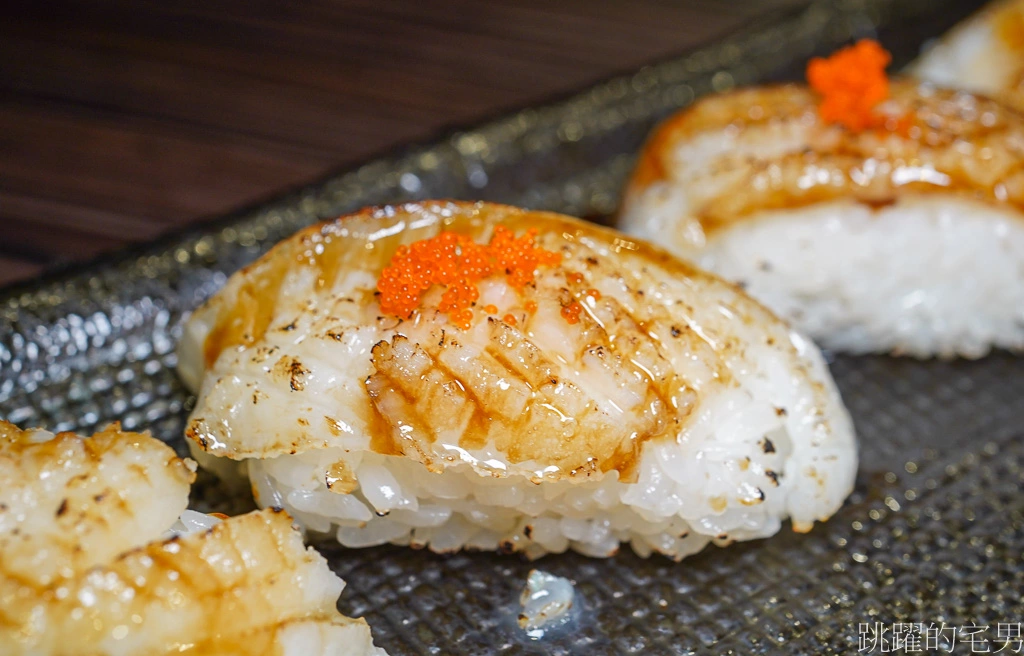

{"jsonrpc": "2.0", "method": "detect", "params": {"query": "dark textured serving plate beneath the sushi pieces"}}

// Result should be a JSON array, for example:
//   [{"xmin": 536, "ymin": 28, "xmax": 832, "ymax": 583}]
[{"xmin": 0, "ymin": 0, "xmax": 1024, "ymax": 654}]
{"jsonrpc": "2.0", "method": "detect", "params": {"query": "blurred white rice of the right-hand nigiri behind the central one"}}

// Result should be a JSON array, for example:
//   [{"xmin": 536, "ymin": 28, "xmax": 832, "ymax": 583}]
[{"xmin": 626, "ymin": 188, "xmax": 1024, "ymax": 357}]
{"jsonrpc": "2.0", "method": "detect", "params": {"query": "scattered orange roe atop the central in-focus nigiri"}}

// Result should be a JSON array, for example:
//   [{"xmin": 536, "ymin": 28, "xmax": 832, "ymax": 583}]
[{"xmin": 377, "ymin": 226, "xmax": 561, "ymax": 329}]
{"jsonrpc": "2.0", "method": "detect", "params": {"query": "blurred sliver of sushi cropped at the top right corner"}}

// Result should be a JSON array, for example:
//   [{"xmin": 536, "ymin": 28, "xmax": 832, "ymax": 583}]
[{"xmin": 907, "ymin": 0, "xmax": 1024, "ymax": 112}]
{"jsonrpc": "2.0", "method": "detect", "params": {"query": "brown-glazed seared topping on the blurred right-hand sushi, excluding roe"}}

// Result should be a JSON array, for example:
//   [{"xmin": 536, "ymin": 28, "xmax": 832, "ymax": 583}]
[{"xmin": 626, "ymin": 80, "xmax": 1024, "ymax": 233}]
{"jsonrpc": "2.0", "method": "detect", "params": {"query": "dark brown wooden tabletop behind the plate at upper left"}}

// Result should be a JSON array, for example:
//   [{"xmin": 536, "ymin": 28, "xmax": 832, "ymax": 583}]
[{"xmin": 0, "ymin": 0, "xmax": 800, "ymax": 285}]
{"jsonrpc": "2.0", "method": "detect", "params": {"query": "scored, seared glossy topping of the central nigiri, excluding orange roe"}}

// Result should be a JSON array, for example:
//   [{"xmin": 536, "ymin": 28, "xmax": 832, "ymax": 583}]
[{"xmin": 182, "ymin": 203, "xmax": 825, "ymax": 481}]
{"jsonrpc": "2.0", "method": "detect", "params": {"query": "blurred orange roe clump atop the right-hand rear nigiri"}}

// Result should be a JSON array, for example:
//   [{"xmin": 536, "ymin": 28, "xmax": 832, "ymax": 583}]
[{"xmin": 807, "ymin": 39, "xmax": 892, "ymax": 132}]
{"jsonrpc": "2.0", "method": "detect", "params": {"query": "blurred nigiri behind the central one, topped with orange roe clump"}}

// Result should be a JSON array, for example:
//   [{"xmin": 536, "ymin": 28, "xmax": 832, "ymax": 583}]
[{"xmin": 620, "ymin": 43, "xmax": 1024, "ymax": 357}]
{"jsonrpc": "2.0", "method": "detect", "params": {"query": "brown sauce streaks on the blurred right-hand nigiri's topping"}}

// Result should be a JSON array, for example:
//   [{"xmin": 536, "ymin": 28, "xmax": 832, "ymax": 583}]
[{"xmin": 630, "ymin": 81, "xmax": 1024, "ymax": 232}]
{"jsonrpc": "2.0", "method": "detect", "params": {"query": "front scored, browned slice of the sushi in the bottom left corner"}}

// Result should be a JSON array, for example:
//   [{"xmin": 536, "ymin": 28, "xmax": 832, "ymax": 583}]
[{"xmin": 0, "ymin": 510, "xmax": 372, "ymax": 655}]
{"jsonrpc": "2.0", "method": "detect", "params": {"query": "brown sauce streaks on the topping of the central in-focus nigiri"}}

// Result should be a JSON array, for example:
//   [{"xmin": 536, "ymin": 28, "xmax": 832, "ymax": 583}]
[{"xmin": 193, "ymin": 203, "xmax": 782, "ymax": 481}]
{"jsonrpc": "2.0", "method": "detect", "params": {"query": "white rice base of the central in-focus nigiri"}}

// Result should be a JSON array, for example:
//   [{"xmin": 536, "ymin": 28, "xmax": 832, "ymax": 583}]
[{"xmin": 241, "ymin": 334, "xmax": 856, "ymax": 560}]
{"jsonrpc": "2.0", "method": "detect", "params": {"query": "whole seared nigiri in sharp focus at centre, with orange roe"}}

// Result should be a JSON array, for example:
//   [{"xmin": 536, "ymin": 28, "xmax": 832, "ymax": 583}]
[{"xmin": 179, "ymin": 202, "xmax": 856, "ymax": 559}]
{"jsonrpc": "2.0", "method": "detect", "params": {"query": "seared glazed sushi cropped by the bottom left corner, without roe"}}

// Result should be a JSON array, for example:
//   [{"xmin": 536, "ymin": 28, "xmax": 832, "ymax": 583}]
[{"xmin": 0, "ymin": 423, "xmax": 383, "ymax": 656}]
